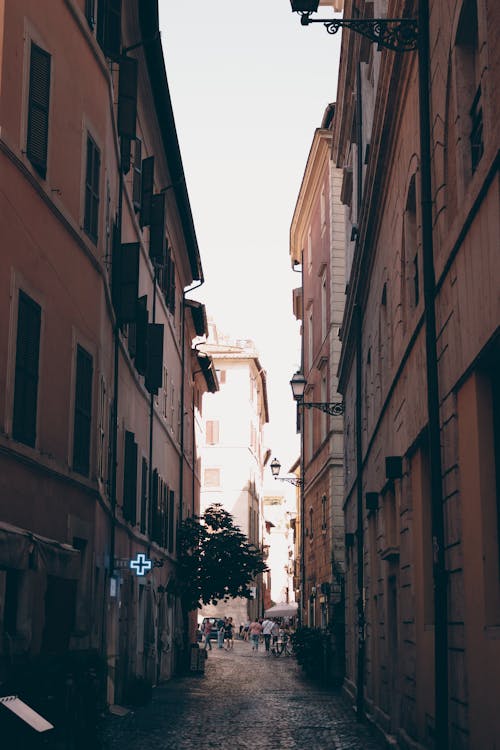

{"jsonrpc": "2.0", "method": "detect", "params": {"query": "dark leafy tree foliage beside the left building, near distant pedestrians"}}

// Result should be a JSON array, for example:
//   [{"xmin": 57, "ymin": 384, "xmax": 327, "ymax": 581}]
[{"xmin": 178, "ymin": 503, "xmax": 267, "ymax": 609}]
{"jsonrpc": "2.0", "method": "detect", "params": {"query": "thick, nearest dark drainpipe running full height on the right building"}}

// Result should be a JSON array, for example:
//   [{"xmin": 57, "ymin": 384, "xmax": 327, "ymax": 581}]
[{"xmin": 418, "ymin": 0, "xmax": 449, "ymax": 750}]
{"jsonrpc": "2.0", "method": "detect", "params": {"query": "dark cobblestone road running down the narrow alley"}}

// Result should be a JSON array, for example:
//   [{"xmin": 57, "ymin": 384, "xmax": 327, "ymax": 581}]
[{"xmin": 104, "ymin": 641, "xmax": 385, "ymax": 750}]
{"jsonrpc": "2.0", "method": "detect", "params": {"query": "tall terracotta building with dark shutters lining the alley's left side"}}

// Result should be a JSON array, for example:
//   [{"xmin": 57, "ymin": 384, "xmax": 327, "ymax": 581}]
[{"xmin": 0, "ymin": 0, "xmax": 216, "ymax": 716}]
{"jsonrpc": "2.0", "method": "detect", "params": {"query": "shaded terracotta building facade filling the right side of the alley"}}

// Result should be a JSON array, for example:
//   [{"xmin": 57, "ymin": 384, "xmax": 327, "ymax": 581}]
[{"xmin": 334, "ymin": 0, "xmax": 500, "ymax": 750}]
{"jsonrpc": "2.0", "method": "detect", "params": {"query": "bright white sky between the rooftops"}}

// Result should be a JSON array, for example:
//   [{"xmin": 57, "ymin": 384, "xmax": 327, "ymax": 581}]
[{"xmin": 159, "ymin": 0, "xmax": 340, "ymax": 491}]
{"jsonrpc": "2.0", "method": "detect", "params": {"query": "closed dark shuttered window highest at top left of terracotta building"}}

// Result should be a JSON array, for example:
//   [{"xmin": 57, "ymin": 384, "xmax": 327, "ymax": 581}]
[{"xmin": 26, "ymin": 42, "xmax": 50, "ymax": 178}]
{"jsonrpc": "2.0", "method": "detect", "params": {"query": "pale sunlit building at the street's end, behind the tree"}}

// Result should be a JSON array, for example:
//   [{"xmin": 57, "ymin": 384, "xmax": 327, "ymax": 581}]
[{"xmin": 199, "ymin": 323, "xmax": 269, "ymax": 626}]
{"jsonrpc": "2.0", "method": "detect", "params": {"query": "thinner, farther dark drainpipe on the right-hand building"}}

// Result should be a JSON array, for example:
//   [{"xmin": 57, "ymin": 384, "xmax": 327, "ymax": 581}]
[{"xmin": 354, "ymin": 62, "xmax": 365, "ymax": 721}]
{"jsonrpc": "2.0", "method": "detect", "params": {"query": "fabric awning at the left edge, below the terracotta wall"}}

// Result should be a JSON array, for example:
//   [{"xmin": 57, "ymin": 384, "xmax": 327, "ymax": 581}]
[{"xmin": 0, "ymin": 521, "xmax": 81, "ymax": 579}]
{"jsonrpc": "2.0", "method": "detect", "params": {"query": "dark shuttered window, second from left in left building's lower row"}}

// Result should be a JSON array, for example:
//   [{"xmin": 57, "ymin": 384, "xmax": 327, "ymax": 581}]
[{"xmin": 73, "ymin": 345, "xmax": 93, "ymax": 476}]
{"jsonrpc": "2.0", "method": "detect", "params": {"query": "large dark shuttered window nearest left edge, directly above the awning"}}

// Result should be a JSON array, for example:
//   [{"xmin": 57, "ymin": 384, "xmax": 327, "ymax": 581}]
[{"xmin": 12, "ymin": 290, "xmax": 41, "ymax": 447}]
